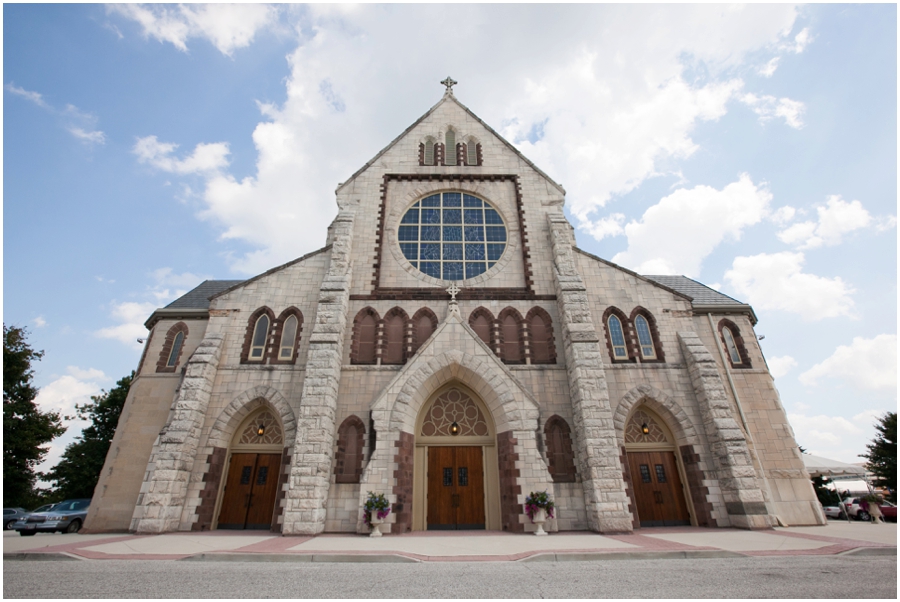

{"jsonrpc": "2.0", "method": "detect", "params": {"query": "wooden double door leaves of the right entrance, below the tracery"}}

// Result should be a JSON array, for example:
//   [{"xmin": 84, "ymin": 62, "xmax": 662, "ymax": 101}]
[{"xmin": 627, "ymin": 451, "xmax": 691, "ymax": 527}]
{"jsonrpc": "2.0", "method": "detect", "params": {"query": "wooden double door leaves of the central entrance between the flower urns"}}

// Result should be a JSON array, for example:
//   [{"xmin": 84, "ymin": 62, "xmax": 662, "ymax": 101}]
[{"xmin": 426, "ymin": 446, "xmax": 485, "ymax": 530}]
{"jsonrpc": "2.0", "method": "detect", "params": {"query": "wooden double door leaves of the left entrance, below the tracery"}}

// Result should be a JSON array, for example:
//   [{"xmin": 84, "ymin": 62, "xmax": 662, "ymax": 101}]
[{"xmin": 218, "ymin": 453, "xmax": 281, "ymax": 530}]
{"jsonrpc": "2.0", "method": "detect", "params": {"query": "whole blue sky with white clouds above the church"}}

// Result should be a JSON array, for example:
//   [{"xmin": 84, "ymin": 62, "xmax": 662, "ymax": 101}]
[{"xmin": 3, "ymin": 4, "xmax": 897, "ymax": 468}]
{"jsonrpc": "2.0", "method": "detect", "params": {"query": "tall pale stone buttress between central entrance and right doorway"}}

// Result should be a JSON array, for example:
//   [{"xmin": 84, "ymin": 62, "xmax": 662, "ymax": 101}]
[{"xmin": 548, "ymin": 212, "xmax": 632, "ymax": 533}]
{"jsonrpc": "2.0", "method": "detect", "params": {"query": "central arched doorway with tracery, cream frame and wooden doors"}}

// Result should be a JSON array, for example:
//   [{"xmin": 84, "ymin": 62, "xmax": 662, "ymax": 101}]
[{"xmin": 412, "ymin": 383, "xmax": 501, "ymax": 531}]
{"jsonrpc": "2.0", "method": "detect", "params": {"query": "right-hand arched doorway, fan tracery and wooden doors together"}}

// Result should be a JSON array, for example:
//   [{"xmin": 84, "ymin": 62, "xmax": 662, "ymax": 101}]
[{"xmin": 625, "ymin": 407, "xmax": 691, "ymax": 527}]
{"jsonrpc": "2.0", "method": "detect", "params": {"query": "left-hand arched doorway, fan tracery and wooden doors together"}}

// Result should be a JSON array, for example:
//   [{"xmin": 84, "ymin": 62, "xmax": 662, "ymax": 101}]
[{"xmin": 216, "ymin": 408, "xmax": 284, "ymax": 530}]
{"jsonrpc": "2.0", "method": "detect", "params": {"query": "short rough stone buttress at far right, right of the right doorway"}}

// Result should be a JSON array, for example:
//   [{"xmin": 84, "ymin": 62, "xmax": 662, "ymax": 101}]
[{"xmin": 678, "ymin": 332, "xmax": 773, "ymax": 529}]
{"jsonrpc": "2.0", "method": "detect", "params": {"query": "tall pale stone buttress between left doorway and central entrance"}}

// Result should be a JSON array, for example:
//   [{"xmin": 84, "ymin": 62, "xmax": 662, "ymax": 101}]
[{"xmin": 282, "ymin": 208, "xmax": 355, "ymax": 535}]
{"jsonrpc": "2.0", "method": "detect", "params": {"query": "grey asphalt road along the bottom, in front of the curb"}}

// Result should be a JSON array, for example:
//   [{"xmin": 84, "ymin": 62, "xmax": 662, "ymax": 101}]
[{"xmin": 3, "ymin": 556, "xmax": 897, "ymax": 599}]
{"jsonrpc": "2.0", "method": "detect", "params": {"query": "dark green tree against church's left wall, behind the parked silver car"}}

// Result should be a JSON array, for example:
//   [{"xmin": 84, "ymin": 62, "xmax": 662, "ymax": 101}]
[{"xmin": 47, "ymin": 372, "xmax": 134, "ymax": 500}]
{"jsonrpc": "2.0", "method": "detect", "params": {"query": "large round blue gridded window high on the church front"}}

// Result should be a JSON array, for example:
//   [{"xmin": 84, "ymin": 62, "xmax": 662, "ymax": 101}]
[{"xmin": 397, "ymin": 192, "xmax": 507, "ymax": 280}]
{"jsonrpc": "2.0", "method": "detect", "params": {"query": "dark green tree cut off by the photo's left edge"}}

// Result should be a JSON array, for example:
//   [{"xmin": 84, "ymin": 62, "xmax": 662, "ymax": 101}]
[{"xmin": 3, "ymin": 324, "xmax": 66, "ymax": 508}]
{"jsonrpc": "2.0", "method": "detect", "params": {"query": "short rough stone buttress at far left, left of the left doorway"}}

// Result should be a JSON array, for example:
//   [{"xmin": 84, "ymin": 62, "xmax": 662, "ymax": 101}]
[{"xmin": 131, "ymin": 334, "xmax": 223, "ymax": 533}]
